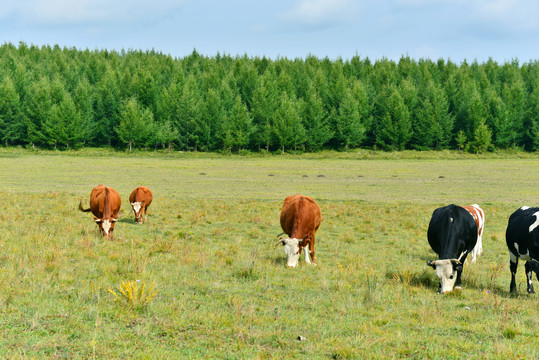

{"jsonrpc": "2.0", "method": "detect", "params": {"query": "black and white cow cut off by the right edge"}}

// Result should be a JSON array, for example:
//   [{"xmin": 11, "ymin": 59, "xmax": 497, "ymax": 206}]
[{"xmin": 505, "ymin": 206, "xmax": 539, "ymax": 294}]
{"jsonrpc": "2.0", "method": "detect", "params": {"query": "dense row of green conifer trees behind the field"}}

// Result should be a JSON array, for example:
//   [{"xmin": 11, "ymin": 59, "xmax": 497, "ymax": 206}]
[{"xmin": 0, "ymin": 42, "xmax": 539, "ymax": 152}]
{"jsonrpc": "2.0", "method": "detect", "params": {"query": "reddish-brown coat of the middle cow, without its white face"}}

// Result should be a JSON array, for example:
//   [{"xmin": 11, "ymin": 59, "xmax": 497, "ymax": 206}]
[{"xmin": 281, "ymin": 195, "xmax": 322, "ymax": 264}]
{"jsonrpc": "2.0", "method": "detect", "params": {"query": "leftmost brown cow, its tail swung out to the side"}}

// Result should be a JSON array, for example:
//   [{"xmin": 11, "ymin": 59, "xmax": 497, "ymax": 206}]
[{"xmin": 79, "ymin": 185, "xmax": 122, "ymax": 239}]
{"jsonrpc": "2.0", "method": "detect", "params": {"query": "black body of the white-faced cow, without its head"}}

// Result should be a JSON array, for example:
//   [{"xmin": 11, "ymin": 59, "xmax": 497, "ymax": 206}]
[{"xmin": 427, "ymin": 204, "xmax": 477, "ymax": 259}]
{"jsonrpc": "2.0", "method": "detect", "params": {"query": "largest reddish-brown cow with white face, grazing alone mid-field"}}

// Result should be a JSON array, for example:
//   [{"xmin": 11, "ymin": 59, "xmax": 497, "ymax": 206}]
[{"xmin": 275, "ymin": 195, "xmax": 322, "ymax": 267}]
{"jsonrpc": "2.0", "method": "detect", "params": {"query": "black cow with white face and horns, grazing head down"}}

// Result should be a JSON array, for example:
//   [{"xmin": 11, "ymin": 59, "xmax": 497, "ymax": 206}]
[{"xmin": 427, "ymin": 204, "xmax": 477, "ymax": 294}]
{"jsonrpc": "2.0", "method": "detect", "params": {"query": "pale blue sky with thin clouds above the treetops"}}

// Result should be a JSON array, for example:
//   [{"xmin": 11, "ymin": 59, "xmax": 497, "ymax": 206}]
[{"xmin": 0, "ymin": 0, "xmax": 539, "ymax": 63}]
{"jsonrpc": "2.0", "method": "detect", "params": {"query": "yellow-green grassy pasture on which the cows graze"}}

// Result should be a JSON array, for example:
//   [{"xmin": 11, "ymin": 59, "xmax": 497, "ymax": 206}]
[{"xmin": 0, "ymin": 152, "xmax": 539, "ymax": 359}]
